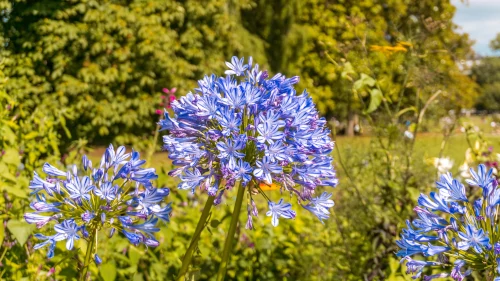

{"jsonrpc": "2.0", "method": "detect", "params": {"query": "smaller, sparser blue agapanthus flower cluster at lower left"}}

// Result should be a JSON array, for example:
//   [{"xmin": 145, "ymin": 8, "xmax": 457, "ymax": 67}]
[{"xmin": 24, "ymin": 145, "xmax": 172, "ymax": 264}]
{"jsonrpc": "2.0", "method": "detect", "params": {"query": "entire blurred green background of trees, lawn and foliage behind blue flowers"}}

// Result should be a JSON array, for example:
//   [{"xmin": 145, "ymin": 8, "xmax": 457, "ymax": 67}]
[{"xmin": 0, "ymin": 0, "xmax": 500, "ymax": 281}]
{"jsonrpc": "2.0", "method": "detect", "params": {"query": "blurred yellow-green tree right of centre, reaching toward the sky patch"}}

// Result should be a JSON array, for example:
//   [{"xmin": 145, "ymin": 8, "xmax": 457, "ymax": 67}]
[{"xmin": 243, "ymin": 0, "xmax": 475, "ymax": 128}]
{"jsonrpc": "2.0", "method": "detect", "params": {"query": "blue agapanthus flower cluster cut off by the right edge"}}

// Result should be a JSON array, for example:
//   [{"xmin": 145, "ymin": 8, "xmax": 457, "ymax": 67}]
[{"xmin": 396, "ymin": 165, "xmax": 500, "ymax": 281}]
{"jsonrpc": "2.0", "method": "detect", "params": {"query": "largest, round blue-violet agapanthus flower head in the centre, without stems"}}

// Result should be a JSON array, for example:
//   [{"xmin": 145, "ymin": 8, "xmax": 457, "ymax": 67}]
[{"xmin": 159, "ymin": 57, "xmax": 337, "ymax": 228}]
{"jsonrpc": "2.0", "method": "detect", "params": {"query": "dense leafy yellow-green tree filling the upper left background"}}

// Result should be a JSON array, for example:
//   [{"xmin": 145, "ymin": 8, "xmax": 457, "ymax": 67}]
[{"xmin": 0, "ymin": 0, "xmax": 262, "ymax": 148}]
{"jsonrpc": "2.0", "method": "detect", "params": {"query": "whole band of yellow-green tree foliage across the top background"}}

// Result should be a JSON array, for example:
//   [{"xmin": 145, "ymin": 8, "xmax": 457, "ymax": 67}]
[{"xmin": 0, "ymin": 0, "xmax": 474, "ymax": 145}]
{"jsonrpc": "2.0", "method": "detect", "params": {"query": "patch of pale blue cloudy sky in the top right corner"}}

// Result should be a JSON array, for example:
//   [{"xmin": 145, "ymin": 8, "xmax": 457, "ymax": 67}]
[{"xmin": 451, "ymin": 0, "xmax": 500, "ymax": 56}]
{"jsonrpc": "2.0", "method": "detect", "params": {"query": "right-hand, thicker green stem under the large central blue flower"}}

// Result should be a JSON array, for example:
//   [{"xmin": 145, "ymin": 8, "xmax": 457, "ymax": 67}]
[{"xmin": 217, "ymin": 185, "xmax": 245, "ymax": 281}]
